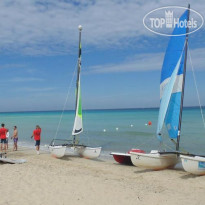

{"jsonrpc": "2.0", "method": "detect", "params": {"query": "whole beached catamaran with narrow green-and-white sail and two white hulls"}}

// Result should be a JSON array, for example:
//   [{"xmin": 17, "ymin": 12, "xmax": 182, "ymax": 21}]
[{"xmin": 49, "ymin": 25, "xmax": 102, "ymax": 159}]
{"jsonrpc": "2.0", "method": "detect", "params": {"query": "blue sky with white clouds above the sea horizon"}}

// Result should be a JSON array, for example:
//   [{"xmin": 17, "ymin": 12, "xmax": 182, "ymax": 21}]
[{"xmin": 0, "ymin": 0, "xmax": 205, "ymax": 112}]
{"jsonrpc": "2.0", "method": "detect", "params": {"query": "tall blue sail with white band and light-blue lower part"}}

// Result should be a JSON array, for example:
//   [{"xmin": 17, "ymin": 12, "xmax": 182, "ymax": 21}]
[{"xmin": 157, "ymin": 10, "xmax": 189, "ymax": 141}]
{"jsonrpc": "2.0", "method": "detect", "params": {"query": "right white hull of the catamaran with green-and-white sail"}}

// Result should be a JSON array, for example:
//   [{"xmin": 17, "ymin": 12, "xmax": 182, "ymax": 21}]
[{"xmin": 75, "ymin": 146, "xmax": 102, "ymax": 159}]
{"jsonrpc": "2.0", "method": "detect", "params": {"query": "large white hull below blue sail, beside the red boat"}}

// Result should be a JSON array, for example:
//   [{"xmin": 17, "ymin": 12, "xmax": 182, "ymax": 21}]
[{"xmin": 130, "ymin": 151, "xmax": 178, "ymax": 170}]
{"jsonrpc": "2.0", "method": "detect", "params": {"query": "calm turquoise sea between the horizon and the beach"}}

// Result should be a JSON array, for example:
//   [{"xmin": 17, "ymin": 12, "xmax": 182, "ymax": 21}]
[{"xmin": 0, "ymin": 108, "xmax": 205, "ymax": 154}]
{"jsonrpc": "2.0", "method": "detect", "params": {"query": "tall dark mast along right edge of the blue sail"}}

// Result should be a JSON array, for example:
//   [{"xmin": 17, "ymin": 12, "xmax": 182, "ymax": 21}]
[{"xmin": 176, "ymin": 4, "xmax": 190, "ymax": 151}]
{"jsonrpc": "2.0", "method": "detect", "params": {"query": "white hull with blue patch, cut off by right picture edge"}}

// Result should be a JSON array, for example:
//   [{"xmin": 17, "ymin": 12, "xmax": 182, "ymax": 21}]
[{"xmin": 180, "ymin": 155, "xmax": 205, "ymax": 175}]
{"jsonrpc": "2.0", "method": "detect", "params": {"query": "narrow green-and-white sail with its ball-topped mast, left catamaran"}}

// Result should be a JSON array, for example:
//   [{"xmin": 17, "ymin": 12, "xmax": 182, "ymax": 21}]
[{"xmin": 72, "ymin": 26, "xmax": 83, "ymax": 136}]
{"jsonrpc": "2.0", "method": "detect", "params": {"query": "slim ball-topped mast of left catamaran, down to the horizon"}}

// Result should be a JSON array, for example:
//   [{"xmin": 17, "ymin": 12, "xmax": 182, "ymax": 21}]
[{"xmin": 75, "ymin": 25, "xmax": 82, "ymax": 110}]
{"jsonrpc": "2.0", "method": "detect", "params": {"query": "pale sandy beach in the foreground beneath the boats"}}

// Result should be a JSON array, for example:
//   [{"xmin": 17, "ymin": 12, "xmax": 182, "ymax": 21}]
[{"xmin": 0, "ymin": 148, "xmax": 205, "ymax": 205}]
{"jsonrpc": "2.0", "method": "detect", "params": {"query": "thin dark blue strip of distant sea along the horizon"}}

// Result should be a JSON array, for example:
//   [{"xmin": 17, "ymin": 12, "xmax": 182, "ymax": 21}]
[{"xmin": 0, "ymin": 106, "xmax": 205, "ymax": 114}]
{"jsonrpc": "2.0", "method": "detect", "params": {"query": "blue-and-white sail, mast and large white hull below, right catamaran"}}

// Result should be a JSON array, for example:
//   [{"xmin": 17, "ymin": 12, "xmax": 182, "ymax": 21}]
[{"xmin": 130, "ymin": 5, "xmax": 190, "ymax": 170}]
